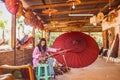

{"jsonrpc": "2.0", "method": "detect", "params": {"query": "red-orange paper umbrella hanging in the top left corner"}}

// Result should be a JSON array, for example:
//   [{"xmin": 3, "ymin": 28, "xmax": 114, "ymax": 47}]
[{"xmin": 5, "ymin": 0, "xmax": 19, "ymax": 14}]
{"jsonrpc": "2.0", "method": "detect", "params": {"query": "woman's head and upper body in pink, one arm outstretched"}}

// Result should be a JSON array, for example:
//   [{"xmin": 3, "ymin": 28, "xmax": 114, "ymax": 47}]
[{"xmin": 32, "ymin": 38, "xmax": 60, "ymax": 68}]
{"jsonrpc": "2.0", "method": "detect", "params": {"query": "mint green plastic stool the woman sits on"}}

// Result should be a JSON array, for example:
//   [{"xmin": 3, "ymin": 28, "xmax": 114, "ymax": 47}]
[{"xmin": 36, "ymin": 63, "xmax": 51, "ymax": 80}]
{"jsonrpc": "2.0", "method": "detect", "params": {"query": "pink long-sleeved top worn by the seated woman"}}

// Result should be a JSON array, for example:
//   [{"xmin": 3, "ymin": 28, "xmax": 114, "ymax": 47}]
[{"xmin": 32, "ymin": 46, "xmax": 57, "ymax": 67}]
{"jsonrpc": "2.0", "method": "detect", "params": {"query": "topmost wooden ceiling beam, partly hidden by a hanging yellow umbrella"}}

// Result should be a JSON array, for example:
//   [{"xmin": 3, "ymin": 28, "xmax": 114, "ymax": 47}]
[{"xmin": 27, "ymin": 0, "xmax": 109, "ymax": 10}]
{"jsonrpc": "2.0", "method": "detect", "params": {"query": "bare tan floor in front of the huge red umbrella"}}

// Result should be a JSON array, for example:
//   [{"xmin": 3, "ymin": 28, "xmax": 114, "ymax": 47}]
[{"xmin": 56, "ymin": 58, "xmax": 120, "ymax": 80}]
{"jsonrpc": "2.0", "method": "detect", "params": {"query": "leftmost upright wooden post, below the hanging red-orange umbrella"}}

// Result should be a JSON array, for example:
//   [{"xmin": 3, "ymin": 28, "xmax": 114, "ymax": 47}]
[{"xmin": 11, "ymin": 15, "xmax": 16, "ymax": 65}]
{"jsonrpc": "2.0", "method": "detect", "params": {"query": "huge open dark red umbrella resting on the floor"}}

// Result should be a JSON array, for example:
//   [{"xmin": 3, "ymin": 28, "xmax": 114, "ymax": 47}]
[{"xmin": 53, "ymin": 32, "xmax": 99, "ymax": 68}]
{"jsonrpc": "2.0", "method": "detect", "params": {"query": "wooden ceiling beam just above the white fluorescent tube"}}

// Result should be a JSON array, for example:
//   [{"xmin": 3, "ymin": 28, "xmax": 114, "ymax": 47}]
[{"xmin": 38, "ymin": 8, "xmax": 100, "ymax": 16}]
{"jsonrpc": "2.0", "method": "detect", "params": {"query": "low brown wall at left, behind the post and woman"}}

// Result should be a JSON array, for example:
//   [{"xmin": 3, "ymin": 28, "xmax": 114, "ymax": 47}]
[{"xmin": 0, "ymin": 49, "xmax": 33, "ymax": 65}]
